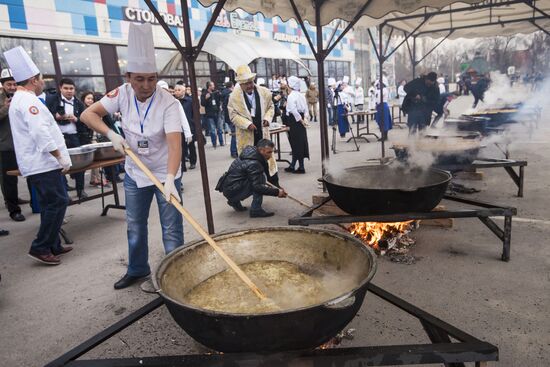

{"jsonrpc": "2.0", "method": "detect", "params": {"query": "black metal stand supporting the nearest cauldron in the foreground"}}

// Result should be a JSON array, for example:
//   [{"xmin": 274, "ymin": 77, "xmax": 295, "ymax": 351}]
[{"xmin": 46, "ymin": 284, "xmax": 498, "ymax": 367}]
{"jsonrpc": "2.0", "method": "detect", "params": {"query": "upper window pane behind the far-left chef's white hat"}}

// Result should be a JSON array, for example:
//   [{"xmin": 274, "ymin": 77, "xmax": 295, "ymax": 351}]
[{"xmin": 0, "ymin": 37, "xmax": 55, "ymax": 75}]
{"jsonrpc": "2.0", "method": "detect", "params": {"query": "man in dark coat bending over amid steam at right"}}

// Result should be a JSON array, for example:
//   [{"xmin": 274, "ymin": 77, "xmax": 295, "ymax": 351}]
[{"xmin": 401, "ymin": 72, "xmax": 439, "ymax": 134}]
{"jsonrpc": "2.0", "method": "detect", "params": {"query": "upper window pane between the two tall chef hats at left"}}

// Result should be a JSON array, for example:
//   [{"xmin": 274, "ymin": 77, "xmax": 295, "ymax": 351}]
[{"xmin": 55, "ymin": 42, "xmax": 103, "ymax": 75}]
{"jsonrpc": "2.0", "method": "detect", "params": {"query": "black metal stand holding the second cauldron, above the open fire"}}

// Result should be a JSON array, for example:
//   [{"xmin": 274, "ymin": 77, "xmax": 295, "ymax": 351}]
[{"xmin": 288, "ymin": 195, "xmax": 517, "ymax": 261}]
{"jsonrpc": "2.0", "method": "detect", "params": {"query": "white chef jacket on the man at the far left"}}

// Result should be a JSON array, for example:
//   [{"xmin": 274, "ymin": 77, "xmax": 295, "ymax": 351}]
[{"xmin": 9, "ymin": 91, "xmax": 70, "ymax": 177}]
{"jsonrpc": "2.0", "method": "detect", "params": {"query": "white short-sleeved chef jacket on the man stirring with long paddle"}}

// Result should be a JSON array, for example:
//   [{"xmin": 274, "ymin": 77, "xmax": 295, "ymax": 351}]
[{"xmin": 100, "ymin": 83, "xmax": 183, "ymax": 188}]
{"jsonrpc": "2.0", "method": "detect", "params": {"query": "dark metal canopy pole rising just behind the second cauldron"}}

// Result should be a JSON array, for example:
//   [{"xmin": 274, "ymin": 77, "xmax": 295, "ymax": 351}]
[{"xmin": 315, "ymin": 0, "xmax": 330, "ymax": 176}]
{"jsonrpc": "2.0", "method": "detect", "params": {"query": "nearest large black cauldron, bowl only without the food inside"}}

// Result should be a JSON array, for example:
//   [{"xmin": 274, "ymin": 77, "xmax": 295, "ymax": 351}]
[{"xmin": 153, "ymin": 227, "xmax": 376, "ymax": 352}]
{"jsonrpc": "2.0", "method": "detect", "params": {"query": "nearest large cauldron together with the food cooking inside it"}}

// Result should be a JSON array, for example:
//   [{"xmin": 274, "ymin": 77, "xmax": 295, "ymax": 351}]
[{"xmin": 153, "ymin": 227, "xmax": 376, "ymax": 352}]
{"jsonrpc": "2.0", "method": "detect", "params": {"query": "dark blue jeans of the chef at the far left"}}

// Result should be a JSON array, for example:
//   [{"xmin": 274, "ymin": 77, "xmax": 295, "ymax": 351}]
[{"xmin": 27, "ymin": 170, "xmax": 69, "ymax": 255}]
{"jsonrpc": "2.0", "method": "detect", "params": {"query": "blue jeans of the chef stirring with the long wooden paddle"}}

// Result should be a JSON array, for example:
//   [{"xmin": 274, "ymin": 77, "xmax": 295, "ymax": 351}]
[{"xmin": 124, "ymin": 175, "xmax": 183, "ymax": 276}]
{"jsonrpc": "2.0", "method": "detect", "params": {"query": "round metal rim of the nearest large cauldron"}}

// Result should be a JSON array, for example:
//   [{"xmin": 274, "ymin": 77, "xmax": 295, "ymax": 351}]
[{"xmin": 152, "ymin": 226, "xmax": 378, "ymax": 318}]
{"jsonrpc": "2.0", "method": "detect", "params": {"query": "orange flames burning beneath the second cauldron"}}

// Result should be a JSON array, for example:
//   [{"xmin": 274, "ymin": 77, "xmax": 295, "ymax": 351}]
[{"xmin": 348, "ymin": 220, "xmax": 414, "ymax": 250}]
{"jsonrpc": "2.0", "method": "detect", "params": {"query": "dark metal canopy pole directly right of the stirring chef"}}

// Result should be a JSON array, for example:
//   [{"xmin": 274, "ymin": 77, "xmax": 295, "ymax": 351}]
[{"xmin": 181, "ymin": 0, "xmax": 215, "ymax": 234}]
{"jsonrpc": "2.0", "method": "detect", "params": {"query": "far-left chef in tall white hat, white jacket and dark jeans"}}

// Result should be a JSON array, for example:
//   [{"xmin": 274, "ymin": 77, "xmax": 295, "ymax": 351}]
[{"xmin": 4, "ymin": 46, "xmax": 72, "ymax": 265}]
